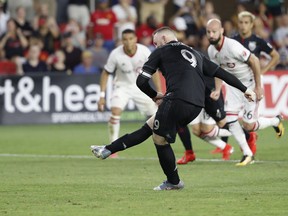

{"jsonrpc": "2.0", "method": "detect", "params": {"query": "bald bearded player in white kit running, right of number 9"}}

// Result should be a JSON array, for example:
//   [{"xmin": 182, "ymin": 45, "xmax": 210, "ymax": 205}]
[{"xmin": 206, "ymin": 19, "xmax": 284, "ymax": 166}]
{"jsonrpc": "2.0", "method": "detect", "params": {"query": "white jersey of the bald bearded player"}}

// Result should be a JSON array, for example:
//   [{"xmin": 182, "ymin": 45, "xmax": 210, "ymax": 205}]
[{"xmin": 208, "ymin": 37, "xmax": 254, "ymax": 85}]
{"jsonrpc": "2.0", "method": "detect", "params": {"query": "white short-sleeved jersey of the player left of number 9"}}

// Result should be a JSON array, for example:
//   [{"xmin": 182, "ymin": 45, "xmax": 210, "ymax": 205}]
[{"xmin": 104, "ymin": 43, "xmax": 151, "ymax": 86}]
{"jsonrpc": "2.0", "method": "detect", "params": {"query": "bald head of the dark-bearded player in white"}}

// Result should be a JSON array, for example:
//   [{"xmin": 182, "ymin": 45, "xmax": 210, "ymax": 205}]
[{"xmin": 206, "ymin": 19, "xmax": 224, "ymax": 46}]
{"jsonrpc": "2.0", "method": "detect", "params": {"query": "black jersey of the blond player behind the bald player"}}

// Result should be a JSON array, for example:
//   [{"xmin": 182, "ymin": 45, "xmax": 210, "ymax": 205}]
[{"xmin": 233, "ymin": 34, "xmax": 273, "ymax": 58}]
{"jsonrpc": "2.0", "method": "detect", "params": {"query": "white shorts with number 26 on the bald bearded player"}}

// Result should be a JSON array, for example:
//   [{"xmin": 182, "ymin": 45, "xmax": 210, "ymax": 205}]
[{"xmin": 225, "ymin": 83, "xmax": 259, "ymax": 123}]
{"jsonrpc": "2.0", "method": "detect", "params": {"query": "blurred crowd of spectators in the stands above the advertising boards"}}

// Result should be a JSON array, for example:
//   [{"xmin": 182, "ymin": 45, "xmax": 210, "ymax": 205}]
[{"xmin": 0, "ymin": 0, "xmax": 288, "ymax": 75}]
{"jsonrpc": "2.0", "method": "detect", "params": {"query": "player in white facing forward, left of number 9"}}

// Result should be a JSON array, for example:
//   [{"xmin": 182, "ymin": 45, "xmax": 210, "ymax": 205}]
[{"xmin": 98, "ymin": 29, "xmax": 161, "ymax": 150}]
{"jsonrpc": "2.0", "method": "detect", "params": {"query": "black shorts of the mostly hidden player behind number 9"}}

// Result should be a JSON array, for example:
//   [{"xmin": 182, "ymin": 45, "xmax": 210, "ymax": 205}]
[{"xmin": 205, "ymin": 92, "xmax": 226, "ymax": 122}]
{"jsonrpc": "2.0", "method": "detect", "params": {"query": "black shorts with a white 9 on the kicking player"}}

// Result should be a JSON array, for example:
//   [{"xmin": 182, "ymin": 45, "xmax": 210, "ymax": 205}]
[{"xmin": 153, "ymin": 98, "xmax": 202, "ymax": 143}]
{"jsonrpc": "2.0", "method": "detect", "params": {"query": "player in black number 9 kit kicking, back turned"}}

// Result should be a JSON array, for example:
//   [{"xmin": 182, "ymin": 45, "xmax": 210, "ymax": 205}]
[{"xmin": 91, "ymin": 27, "xmax": 255, "ymax": 190}]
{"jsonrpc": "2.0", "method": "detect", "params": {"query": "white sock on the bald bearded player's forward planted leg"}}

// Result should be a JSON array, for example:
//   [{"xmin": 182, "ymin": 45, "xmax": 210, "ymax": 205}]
[{"xmin": 229, "ymin": 121, "xmax": 253, "ymax": 156}]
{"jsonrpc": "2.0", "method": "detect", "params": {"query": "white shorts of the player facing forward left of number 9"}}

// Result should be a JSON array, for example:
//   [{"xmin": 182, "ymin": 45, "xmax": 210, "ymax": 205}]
[{"xmin": 111, "ymin": 84, "xmax": 158, "ymax": 116}]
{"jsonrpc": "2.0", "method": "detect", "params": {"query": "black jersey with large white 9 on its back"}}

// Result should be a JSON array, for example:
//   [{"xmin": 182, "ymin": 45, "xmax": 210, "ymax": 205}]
[{"xmin": 143, "ymin": 41, "xmax": 219, "ymax": 107}]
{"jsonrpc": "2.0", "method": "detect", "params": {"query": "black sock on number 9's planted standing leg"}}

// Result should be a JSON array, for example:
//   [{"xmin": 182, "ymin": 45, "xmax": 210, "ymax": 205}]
[{"xmin": 155, "ymin": 144, "xmax": 180, "ymax": 184}]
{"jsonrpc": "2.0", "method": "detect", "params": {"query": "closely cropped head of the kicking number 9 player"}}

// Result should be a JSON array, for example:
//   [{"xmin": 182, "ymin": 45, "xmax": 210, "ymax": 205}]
[{"xmin": 153, "ymin": 27, "xmax": 177, "ymax": 47}]
